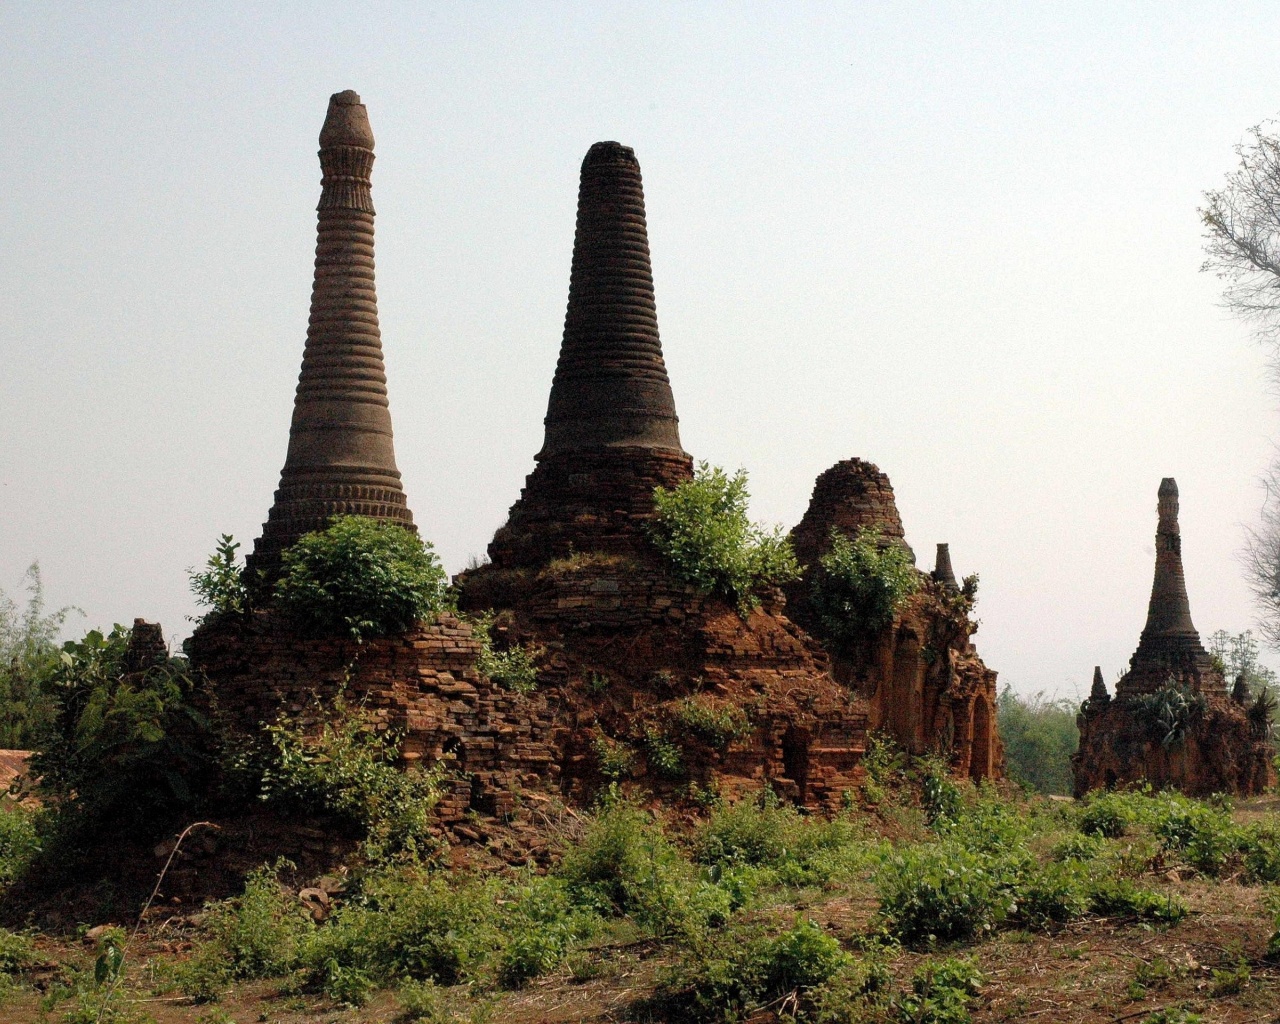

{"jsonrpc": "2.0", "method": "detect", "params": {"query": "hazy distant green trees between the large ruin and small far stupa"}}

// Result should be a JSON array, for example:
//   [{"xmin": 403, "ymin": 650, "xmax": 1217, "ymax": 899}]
[{"xmin": 996, "ymin": 686, "xmax": 1080, "ymax": 796}]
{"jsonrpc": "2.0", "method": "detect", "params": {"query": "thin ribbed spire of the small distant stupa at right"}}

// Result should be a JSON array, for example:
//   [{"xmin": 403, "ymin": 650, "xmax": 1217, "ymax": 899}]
[{"xmin": 1117, "ymin": 476, "xmax": 1222, "ymax": 691}]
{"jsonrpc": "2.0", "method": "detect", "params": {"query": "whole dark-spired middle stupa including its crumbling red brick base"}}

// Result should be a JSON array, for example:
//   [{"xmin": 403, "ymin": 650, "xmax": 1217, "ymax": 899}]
[{"xmin": 457, "ymin": 142, "xmax": 867, "ymax": 806}]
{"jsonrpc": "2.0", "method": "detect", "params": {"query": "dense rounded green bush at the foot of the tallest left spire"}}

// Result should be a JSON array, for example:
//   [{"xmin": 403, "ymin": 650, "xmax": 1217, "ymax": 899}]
[{"xmin": 275, "ymin": 516, "xmax": 449, "ymax": 639}]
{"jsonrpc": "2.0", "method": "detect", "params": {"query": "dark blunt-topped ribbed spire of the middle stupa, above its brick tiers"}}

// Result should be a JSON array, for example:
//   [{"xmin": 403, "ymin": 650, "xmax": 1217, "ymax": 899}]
[{"xmin": 538, "ymin": 142, "xmax": 684, "ymax": 460}]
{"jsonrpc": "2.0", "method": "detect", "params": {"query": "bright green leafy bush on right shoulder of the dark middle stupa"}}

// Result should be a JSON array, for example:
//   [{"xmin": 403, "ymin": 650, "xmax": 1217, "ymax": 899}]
[{"xmin": 652, "ymin": 462, "xmax": 800, "ymax": 612}]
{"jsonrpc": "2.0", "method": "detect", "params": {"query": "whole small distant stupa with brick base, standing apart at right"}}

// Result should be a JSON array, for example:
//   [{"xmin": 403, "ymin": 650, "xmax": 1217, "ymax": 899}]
[{"xmin": 1071, "ymin": 477, "xmax": 1272, "ymax": 796}]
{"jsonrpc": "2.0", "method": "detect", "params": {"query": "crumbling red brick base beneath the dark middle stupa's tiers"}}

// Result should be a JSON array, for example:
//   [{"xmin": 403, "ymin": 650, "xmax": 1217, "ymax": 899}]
[{"xmin": 458, "ymin": 554, "xmax": 867, "ymax": 809}]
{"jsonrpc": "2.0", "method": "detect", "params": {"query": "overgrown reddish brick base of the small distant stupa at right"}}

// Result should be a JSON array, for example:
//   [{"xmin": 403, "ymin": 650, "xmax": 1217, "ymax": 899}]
[{"xmin": 1071, "ymin": 692, "xmax": 1275, "ymax": 797}]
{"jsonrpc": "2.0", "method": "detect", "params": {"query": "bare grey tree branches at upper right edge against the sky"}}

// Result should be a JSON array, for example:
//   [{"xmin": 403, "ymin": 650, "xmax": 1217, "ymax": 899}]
[{"xmin": 1199, "ymin": 122, "xmax": 1280, "ymax": 346}]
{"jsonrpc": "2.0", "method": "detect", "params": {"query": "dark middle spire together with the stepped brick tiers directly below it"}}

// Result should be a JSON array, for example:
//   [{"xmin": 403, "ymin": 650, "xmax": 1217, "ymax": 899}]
[{"xmin": 489, "ymin": 142, "xmax": 692, "ymax": 568}]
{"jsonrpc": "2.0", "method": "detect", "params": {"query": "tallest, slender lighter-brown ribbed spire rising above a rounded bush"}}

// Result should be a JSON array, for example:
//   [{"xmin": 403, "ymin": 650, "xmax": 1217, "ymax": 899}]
[{"xmin": 248, "ymin": 90, "xmax": 413, "ymax": 577}]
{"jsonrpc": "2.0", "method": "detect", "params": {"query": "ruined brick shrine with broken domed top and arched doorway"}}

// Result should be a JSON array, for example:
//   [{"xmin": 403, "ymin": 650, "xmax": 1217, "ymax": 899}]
[{"xmin": 787, "ymin": 458, "xmax": 1004, "ymax": 781}]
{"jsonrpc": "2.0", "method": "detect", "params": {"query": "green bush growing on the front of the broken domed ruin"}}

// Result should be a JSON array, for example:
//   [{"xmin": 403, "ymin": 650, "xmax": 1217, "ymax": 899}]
[{"xmin": 810, "ymin": 529, "xmax": 920, "ymax": 654}]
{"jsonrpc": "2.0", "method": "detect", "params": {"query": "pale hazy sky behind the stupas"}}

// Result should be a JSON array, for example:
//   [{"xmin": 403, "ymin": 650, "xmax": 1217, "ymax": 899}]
[{"xmin": 0, "ymin": 0, "xmax": 1280, "ymax": 692}]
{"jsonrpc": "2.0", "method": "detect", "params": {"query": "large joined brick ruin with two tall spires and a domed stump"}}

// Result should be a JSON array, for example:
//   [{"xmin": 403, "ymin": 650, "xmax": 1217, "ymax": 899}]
[{"xmin": 187, "ymin": 92, "xmax": 1000, "ymax": 827}]
